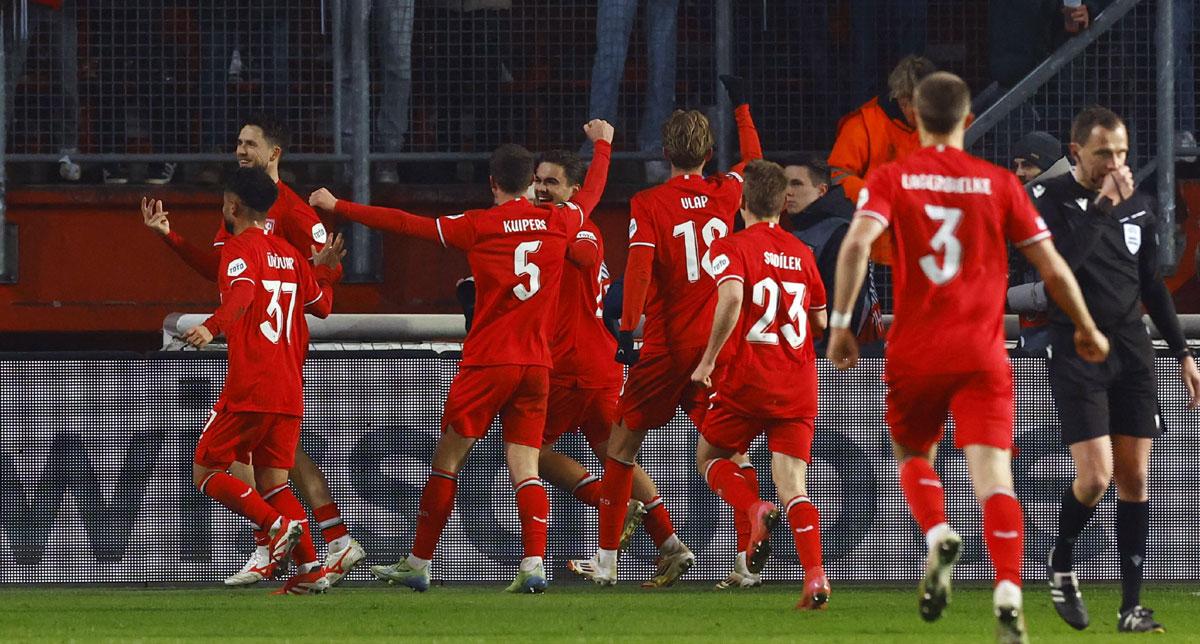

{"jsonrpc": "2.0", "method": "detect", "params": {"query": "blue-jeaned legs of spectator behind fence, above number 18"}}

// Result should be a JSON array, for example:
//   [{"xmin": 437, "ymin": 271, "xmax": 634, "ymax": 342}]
[{"xmin": 582, "ymin": 0, "xmax": 679, "ymax": 183}]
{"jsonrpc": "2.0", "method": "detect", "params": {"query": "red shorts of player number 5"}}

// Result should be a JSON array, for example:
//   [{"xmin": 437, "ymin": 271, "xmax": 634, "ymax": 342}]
[{"xmin": 442, "ymin": 365, "xmax": 550, "ymax": 449}]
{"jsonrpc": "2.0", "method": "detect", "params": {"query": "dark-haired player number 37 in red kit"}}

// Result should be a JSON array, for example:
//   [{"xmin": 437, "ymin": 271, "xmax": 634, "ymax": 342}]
[{"xmin": 184, "ymin": 168, "xmax": 344, "ymax": 594}]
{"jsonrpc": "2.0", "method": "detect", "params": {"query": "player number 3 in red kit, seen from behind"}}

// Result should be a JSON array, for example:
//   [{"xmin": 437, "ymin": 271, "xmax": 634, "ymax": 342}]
[{"xmin": 829, "ymin": 72, "xmax": 1108, "ymax": 642}]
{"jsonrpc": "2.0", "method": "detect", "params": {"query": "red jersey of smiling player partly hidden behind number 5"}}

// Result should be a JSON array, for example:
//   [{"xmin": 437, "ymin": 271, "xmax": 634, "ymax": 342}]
[{"xmin": 550, "ymin": 219, "xmax": 624, "ymax": 389}]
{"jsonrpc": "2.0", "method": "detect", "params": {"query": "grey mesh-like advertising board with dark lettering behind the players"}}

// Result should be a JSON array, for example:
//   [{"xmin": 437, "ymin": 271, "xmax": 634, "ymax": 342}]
[{"xmin": 0, "ymin": 351, "xmax": 1200, "ymax": 583}]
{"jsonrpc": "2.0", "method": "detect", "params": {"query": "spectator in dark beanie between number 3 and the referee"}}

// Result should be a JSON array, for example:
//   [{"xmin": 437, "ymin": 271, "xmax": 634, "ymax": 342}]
[{"xmin": 1008, "ymin": 132, "xmax": 1070, "ymax": 357}]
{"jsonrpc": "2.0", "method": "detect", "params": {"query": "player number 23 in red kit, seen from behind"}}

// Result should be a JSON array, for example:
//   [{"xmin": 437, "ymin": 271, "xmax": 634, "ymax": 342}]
[{"xmin": 691, "ymin": 160, "xmax": 829, "ymax": 608}]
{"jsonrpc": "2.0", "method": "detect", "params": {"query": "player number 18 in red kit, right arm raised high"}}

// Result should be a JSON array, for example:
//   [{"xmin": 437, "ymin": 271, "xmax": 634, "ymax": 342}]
[{"xmin": 568, "ymin": 77, "xmax": 762, "ymax": 586}]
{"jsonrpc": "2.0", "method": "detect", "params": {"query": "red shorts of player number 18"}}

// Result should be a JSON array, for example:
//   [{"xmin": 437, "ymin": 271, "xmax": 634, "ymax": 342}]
[{"xmin": 619, "ymin": 347, "xmax": 720, "ymax": 432}]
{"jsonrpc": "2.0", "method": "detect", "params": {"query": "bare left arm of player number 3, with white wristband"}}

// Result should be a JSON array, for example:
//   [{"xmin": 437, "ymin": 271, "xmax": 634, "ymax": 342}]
[{"xmin": 827, "ymin": 217, "xmax": 887, "ymax": 369}]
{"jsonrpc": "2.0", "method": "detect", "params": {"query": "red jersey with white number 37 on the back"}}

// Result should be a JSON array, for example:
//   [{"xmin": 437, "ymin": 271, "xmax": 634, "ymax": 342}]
[{"xmin": 205, "ymin": 228, "xmax": 325, "ymax": 416}]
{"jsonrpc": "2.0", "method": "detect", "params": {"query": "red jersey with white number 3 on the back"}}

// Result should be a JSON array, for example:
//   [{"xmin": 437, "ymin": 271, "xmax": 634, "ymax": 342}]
[{"xmin": 858, "ymin": 146, "xmax": 1050, "ymax": 374}]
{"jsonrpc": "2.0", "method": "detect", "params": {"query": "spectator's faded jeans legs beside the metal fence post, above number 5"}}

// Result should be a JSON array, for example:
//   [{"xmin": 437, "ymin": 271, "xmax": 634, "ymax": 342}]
[{"xmin": 341, "ymin": 0, "xmax": 416, "ymax": 183}]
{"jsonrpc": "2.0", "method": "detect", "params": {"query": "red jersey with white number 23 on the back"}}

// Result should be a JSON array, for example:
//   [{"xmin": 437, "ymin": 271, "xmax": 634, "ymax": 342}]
[{"xmin": 712, "ymin": 223, "xmax": 826, "ymax": 419}]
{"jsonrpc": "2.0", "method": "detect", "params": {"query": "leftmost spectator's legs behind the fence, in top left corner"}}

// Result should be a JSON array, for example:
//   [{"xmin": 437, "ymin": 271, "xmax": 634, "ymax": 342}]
[{"xmin": 5, "ymin": 0, "xmax": 82, "ymax": 181}]
